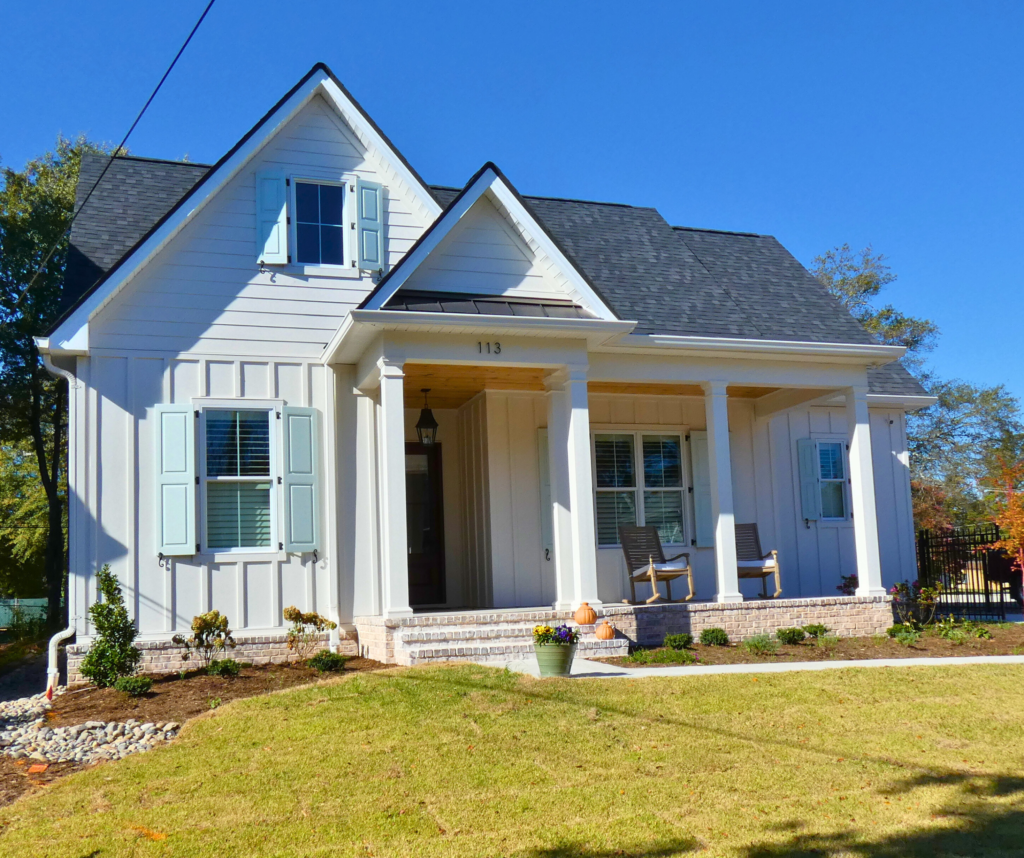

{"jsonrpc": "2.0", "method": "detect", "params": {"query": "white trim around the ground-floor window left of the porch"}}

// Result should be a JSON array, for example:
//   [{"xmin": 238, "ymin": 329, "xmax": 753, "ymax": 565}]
[{"xmin": 191, "ymin": 397, "xmax": 288, "ymax": 563}]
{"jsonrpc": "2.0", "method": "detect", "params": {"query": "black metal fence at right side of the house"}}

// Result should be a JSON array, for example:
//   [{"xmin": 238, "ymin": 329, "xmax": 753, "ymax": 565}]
[{"xmin": 918, "ymin": 524, "xmax": 1021, "ymax": 621}]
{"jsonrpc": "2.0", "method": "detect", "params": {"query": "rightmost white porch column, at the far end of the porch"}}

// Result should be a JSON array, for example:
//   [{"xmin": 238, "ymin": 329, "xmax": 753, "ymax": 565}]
[{"xmin": 846, "ymin": 387, "xmax": 886, "ymax": 596}]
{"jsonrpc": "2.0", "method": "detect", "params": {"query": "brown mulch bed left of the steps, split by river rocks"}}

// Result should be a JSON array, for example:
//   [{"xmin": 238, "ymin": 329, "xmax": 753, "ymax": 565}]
[{"xmin": 0, "ymin": 658, "xmax": 388, "ymax": 807}]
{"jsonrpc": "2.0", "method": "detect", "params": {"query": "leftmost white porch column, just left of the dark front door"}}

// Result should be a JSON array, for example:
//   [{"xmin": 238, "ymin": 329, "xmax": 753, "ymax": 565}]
[{"xmin": 377, "ymin": 357, "xmax": 413, "ymax": 616}]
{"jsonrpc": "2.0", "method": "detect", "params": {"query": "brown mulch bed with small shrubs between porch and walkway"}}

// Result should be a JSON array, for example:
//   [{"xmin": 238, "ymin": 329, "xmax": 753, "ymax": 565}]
[{"xmin": 596, "ymin": 624, "xmax": 1024, "ymax": 668}]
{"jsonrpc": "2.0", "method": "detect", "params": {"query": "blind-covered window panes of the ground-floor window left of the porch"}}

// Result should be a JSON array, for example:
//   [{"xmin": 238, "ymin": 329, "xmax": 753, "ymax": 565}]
[{"xmin": 204, "ymin": 409, "xmax": 273, "ymax": 551}]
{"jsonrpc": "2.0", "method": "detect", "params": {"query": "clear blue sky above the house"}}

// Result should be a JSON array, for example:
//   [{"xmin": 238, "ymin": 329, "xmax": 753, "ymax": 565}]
[{"xmin": 0, "ymin": 0, "xmax": 1024, "ymax": 399}]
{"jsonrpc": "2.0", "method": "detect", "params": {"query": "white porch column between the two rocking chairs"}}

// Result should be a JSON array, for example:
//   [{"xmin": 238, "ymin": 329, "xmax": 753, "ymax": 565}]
[{"xmin": 702, "ymin": 381, "xmax": 743, "ymax": 602}]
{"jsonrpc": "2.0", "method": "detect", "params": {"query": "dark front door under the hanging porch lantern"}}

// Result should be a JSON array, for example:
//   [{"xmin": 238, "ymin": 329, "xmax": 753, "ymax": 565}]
[{"xmin": 406, "ymin": 442, "xmax": 444, "ymax": 607}]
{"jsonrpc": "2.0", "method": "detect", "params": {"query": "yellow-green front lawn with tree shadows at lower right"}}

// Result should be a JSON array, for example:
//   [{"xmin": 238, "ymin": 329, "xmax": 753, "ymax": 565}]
[{"xmin": 0, "ymin": 664, "xmax": 1024, "ymax": 858}]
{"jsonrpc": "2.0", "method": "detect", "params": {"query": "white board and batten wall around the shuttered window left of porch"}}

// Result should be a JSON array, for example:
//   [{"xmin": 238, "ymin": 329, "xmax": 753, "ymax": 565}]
[{"xmin": 71, "ymin": 354, "xmax": 337, "ymax": 638}]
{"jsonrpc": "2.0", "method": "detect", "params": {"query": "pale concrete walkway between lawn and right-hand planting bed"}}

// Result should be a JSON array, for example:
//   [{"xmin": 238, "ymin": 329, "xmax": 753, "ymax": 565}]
[{"xmin": 499, "ymin": 655, "xmax": 1024, "ymax": 679}]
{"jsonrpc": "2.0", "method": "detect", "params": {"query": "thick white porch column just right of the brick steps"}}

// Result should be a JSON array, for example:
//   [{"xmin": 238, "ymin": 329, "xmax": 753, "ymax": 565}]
[{"xmin": 548, "ymin": 368, "xmax": 601, "ymax": 609}]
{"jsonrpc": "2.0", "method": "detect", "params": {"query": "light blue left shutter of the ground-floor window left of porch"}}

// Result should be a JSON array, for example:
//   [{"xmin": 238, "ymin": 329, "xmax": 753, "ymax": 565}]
[{"xmin": 154, "ymin": 405, "xmax": 196, "ymax": 557}]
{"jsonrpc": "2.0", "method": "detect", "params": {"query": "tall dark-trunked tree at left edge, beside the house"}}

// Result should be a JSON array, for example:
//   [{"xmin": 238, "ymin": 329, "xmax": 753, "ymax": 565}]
[{"xmin": 0, "ymin": 137, "xmax": 102, "ymax": 621}]
